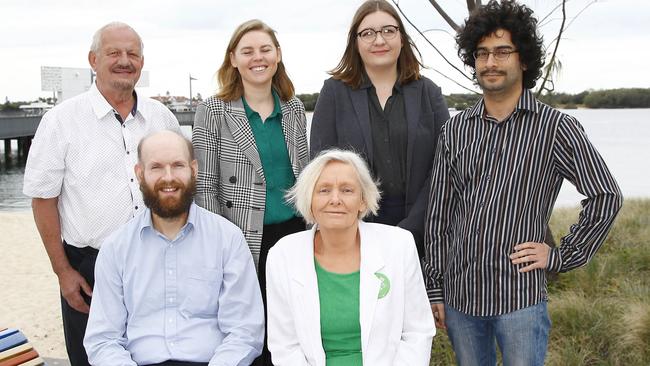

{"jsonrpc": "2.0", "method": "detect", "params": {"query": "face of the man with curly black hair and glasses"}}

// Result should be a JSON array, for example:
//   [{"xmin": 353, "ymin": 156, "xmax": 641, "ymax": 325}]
[{"xmin": 476, "ymin": 29, "xmax": 526, "ymax": 95}]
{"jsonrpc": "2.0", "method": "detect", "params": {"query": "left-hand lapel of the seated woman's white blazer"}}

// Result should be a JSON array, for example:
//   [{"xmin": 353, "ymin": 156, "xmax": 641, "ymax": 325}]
[{"xmin": 289, "ymin": 225, "xmax": 325, "ymax": 366}]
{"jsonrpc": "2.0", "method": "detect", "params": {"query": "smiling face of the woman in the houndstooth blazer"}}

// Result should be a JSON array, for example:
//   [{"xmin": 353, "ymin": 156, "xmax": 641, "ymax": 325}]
[{"xmin": 230, "ymin": 30, "xmax": 281, "ymax": 89}]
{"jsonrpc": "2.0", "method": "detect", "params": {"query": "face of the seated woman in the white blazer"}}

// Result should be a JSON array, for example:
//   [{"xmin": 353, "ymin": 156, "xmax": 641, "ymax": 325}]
[{"xmin": 311, "ymin": 161, "xmax": 366, "ymax": 230}]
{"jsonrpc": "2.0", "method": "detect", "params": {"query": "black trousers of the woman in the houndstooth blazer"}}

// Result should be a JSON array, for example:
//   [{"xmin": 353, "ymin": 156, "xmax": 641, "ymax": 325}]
[{"xmin": 253, "ymin": 217, "xmax": 305, "ymax": 366}]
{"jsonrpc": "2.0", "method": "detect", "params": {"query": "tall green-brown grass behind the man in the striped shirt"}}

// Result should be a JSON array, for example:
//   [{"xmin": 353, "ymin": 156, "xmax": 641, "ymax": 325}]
[{"xmin": 431, "ymin": 199, "xmax": 650, "ymax": 366}]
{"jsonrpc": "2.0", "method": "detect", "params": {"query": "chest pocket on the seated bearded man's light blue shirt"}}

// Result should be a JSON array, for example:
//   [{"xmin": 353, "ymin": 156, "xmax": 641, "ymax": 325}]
[{"xmin": 180, "ymin": 267, "xmax": 223, "ymax": 318}]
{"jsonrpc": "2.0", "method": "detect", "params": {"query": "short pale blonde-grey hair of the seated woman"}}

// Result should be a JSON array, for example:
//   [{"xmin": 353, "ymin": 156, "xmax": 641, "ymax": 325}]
[{"xmin": 285, "ymin": 149, "xmax": 381, "ymax": 224}]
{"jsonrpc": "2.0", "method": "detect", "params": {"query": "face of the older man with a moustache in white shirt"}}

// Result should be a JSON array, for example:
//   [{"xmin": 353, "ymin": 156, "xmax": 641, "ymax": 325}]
[{"xmin": 88, "ymin": 27, "xmax": 144, "ymax": 92}]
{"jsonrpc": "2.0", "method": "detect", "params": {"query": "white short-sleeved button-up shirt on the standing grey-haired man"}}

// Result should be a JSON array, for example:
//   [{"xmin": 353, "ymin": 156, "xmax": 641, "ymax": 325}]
[{"xmin": 23, "ymin": 85, "xmax": 179, "ymax": 249}]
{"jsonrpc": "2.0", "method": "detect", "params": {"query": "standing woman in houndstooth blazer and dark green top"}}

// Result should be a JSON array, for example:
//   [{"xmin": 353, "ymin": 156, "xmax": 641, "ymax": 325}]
[{"xmin": 192, "ymin": 20, "xmax": 309, "ymax": 365}]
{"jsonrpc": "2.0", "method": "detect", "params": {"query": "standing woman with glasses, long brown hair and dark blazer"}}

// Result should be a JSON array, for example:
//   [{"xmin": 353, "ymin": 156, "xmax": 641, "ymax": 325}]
[{"xmin": 310, "ymin": 0, "xmax": 449, "ymax": 256}]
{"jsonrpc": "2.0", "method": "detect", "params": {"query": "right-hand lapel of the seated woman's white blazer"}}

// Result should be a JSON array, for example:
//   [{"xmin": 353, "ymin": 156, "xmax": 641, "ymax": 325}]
[{"xmin": 359, "ymin": 221, "xmax": 384, "ymax": 352}]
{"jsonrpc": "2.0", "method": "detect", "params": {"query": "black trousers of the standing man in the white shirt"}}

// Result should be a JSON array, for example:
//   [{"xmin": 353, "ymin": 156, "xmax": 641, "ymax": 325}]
[{"xmin": 61, "ymin": 242, "xmax": 99, "ymax": 366}]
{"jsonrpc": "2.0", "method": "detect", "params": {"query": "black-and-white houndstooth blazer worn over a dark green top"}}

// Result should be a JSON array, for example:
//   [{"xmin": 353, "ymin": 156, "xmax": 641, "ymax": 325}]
[{"xmin": 192, "ymin": 97, "xmax": 309, "ymax": 266}]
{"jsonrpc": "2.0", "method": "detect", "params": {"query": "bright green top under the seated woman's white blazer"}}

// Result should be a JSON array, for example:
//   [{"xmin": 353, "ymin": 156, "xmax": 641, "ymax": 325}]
[{"xmin": 314, "ymin": 258, "xmax": 363, "ymax": 366}]
